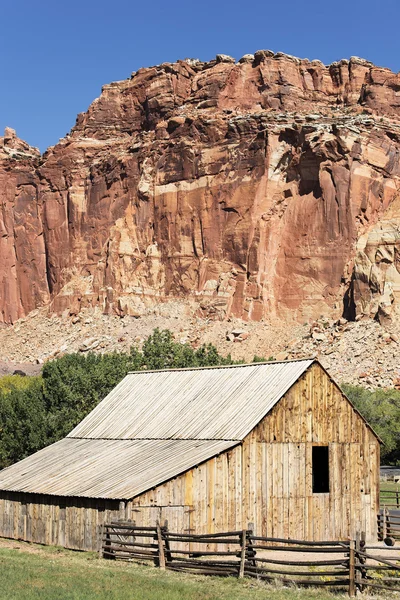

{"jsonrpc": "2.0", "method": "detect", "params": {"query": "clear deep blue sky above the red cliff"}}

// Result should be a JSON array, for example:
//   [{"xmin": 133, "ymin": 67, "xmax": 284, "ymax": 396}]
[{"xmin": 0, "ymin": 0, "xmax": 400, "ymax": 151}]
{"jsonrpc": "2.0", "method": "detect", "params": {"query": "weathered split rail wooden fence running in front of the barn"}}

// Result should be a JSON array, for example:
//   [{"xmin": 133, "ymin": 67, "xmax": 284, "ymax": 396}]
[{"xmin": 100, "ymin": 522, "xmax": 400, "ymax": 597}]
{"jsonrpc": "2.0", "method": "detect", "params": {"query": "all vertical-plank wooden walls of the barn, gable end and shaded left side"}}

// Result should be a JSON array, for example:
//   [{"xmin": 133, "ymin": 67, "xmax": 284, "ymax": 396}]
[{"xmin": 0, "ymin": 364, "xmax": 380, "ymax": 550}]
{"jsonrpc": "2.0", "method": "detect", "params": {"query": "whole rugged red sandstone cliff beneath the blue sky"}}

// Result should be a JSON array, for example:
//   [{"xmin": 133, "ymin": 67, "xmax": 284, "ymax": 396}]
[{"xmin": 0, "ymin": 51, "xmax": 400, "ymax": 323}]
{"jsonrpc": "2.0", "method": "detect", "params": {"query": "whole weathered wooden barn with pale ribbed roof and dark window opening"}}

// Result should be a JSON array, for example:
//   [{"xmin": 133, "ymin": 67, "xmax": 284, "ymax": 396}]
[{"xmin": 0, "ymin": 360, "xmax": 379, "ymax": 549}]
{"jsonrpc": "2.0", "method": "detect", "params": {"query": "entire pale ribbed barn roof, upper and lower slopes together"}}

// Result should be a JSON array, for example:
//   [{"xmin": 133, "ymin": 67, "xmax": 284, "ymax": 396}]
[{"xmin": 0, "ymin": 360, "xmax": 313, "ymax": 499}]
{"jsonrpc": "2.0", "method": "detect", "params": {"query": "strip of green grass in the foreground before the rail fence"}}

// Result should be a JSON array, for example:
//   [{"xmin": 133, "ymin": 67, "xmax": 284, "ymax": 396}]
[{"xmin": 0, "ymin": 542, "xmax": 350, "ymax": 600}]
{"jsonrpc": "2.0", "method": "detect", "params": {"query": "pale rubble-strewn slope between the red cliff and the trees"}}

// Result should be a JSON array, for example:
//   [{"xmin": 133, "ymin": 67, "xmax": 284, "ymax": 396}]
[{"xmin": 0, "ymin": 300, "xmax": 400, "ymax": 389}]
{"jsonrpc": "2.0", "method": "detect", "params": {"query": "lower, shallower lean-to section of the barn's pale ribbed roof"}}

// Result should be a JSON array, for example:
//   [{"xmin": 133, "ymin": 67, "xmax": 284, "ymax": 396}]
[{"xmin": 0, "ymin": 438, "xmax": 237, "ymax": 499}]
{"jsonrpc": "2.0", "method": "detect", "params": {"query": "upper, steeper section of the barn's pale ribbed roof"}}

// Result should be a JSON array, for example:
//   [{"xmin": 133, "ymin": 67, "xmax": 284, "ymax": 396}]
[{"xmin": 68, "ymin": 360, "xmax": 313, "ymax": 440}]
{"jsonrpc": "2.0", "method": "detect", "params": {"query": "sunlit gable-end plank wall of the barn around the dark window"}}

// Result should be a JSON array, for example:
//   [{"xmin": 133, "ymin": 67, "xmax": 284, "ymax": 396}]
[{"xmin": 130, "ymin": 365, "xmax": 379, "ymax": 541}]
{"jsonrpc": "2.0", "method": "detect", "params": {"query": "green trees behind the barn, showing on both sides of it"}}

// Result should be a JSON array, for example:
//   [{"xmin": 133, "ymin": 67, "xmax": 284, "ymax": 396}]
[{"xmin": 0, "ymin": 329, "xmax": 400, "ymax": 468}]
